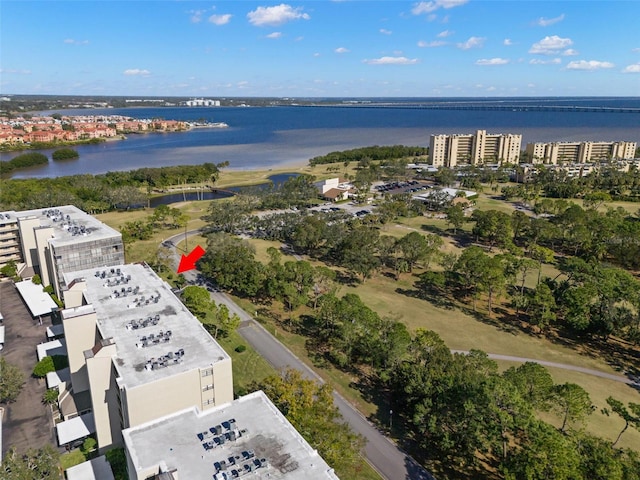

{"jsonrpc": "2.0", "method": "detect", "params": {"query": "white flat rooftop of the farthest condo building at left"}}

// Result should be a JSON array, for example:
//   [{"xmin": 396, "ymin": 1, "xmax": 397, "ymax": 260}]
[{"xmin": 15, "ymin": 205, "xmax": 121, "ymax": 247}]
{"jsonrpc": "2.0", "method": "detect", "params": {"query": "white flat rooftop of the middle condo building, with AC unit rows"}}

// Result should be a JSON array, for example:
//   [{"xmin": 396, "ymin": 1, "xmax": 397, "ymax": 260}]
[{"xmin": 63, "ymin": 264, "xmax": 229, "ymax": 388}]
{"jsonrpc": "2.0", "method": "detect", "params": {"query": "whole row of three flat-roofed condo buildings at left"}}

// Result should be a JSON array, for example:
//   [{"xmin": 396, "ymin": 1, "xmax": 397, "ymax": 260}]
[{"xmin": 0, "ymin": 206, "xmax": 338, "ymax": 480}]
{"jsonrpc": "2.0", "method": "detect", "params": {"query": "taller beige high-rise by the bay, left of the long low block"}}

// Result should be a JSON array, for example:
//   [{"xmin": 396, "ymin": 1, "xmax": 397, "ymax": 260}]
[{"xmin": 429, "ymin": 130, "xmax": 522, "ymax": 168}]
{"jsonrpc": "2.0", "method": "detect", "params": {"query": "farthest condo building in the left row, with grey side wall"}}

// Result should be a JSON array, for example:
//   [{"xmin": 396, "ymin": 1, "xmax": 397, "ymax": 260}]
[{"xmin": 0, "ymin": 205, "xmax": 124, "ymax": 298}]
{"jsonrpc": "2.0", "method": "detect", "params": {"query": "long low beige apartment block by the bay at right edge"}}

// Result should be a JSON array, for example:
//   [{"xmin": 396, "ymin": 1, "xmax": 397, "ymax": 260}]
[{"xmin": 526, "ymin": 142, "xmax": 637, "ymax": 165}]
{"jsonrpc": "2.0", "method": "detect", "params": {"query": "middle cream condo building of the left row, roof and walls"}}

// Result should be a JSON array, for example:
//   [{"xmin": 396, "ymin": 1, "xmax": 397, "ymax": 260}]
[{"xmin": 56, "ymin": 264, "xmax": 233, "ymax": 451}]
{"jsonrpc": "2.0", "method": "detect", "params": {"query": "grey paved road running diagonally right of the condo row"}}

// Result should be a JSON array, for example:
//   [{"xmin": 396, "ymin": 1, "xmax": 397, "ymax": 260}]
[{"xmin": 167, "ymin": 231, "xmax": 434, "ymax": 480}]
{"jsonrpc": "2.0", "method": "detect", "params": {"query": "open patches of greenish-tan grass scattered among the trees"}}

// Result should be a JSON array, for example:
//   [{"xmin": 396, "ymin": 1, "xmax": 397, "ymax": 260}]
[{"xmin": 98, "ymin": 180, "xmax": 640, "ymax": 458}]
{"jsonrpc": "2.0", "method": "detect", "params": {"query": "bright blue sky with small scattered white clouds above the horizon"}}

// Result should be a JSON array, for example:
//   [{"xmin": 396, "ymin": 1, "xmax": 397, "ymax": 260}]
[{"xmin": 0, "ymin": 0, "xmax": 640, "ymax": 98}]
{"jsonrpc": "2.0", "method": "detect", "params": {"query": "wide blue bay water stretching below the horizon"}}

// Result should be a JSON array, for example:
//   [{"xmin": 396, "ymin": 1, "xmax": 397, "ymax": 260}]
[{"xmin": 0, "ymin": 97, "xmax": 640, "ymax": 178}]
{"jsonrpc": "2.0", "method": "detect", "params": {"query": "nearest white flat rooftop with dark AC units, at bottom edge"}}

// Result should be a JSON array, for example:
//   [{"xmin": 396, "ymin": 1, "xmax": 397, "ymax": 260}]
[{"xmin": 122, "ymin": 391, "xmax": 338, "ymax": 480}]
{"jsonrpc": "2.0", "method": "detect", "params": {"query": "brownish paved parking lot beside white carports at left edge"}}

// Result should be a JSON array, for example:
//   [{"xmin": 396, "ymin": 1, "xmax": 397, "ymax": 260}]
[{"xmin": 0, "ymin": 281, "xmax": 57, "ymax": 455}]
